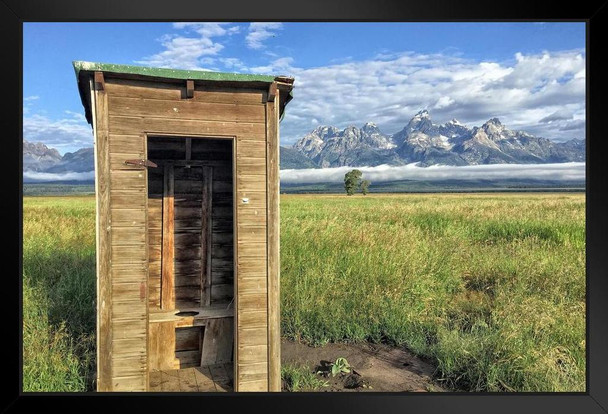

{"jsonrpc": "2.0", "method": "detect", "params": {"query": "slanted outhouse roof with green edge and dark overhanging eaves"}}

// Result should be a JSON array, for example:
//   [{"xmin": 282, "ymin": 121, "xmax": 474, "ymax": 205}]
[{"xmin": 72, "ymin": 61, "xmax": 294, "ymax": 123}]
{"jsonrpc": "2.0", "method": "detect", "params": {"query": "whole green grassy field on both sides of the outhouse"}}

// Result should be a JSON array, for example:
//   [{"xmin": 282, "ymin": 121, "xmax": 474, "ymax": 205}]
[{"xmin": 23, "ymin": 194, "xmax": 585, "ymax": 391}]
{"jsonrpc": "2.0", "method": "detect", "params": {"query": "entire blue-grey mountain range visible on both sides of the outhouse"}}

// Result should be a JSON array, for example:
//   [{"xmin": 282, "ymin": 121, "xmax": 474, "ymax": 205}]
[{"xmin": 23, "ymin": 110, "xmax": 585, "ymax": 181}]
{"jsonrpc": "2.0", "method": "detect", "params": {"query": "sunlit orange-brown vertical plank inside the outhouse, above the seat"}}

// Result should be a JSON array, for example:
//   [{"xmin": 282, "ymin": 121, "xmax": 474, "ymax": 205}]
[{"xmin": 160, "ymin": 166, "xmax": 175, "ymax": 309}]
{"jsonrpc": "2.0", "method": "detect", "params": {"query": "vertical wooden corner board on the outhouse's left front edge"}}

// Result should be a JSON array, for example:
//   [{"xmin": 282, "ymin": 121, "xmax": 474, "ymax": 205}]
[{"xmin": 90, "ymin": 78, "xmax": 114, "ymax": 391}]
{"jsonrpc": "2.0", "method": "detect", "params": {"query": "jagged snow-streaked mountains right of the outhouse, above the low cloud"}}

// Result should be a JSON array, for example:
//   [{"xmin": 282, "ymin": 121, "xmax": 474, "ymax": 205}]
[{"xmin": 293, "ymin": 109, "xmax": 585, "ymax": 168}]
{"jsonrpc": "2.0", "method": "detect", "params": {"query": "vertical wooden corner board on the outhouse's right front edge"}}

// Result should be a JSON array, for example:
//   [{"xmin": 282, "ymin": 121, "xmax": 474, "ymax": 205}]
[{"xmin": 266, "ymin": 91, "xmax": 281, "ymax": 392}]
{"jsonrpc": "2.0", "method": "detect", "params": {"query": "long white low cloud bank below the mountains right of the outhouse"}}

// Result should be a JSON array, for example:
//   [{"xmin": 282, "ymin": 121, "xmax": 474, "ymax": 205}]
[{"xmin": 281, "ymin": 162, "xmax": 585, "ymax": 184}]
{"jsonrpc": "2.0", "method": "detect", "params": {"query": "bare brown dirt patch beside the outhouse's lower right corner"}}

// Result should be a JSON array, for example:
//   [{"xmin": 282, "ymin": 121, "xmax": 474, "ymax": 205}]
[{"xmin": 281, "ymin": 339, "xmax": 447, "ymax": 392}]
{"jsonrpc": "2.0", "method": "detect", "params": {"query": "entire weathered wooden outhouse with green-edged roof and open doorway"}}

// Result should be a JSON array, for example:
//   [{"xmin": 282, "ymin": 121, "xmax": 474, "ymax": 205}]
[{"xmin": 73, "ymin": 62, "xmax": 293, "ymax": 391}]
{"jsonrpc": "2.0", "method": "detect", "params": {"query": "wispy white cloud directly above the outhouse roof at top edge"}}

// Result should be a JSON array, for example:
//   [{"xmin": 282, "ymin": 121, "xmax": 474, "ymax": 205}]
[{"xmin": 136, "ymin": 23, "xmax": 239, "ymax": 70}]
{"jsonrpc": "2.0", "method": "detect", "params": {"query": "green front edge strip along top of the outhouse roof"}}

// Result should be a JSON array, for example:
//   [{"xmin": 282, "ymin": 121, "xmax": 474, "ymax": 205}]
[{"xmin": 72, "ymin": 61, "xmax": 275, "ymax": 83}]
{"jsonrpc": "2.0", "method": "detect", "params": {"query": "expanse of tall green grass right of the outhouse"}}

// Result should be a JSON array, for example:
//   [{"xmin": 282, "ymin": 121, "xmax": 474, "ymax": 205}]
[{"xmin": 281, "ymin": 194, "xmax": 585, "ymax": 391}]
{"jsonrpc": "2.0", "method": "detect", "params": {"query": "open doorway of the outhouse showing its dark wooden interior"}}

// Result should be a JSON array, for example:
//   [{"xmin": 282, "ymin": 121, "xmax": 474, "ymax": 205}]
[{"xmin": 147, "ymin": 137, "xmax": 235, "ymax": 391}]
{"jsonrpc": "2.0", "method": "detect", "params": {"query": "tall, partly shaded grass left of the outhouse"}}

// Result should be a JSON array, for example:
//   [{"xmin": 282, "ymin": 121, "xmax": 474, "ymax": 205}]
[{"xmin": 23, "ymin": 197, "xmax": 95, "ymax": 391}]
